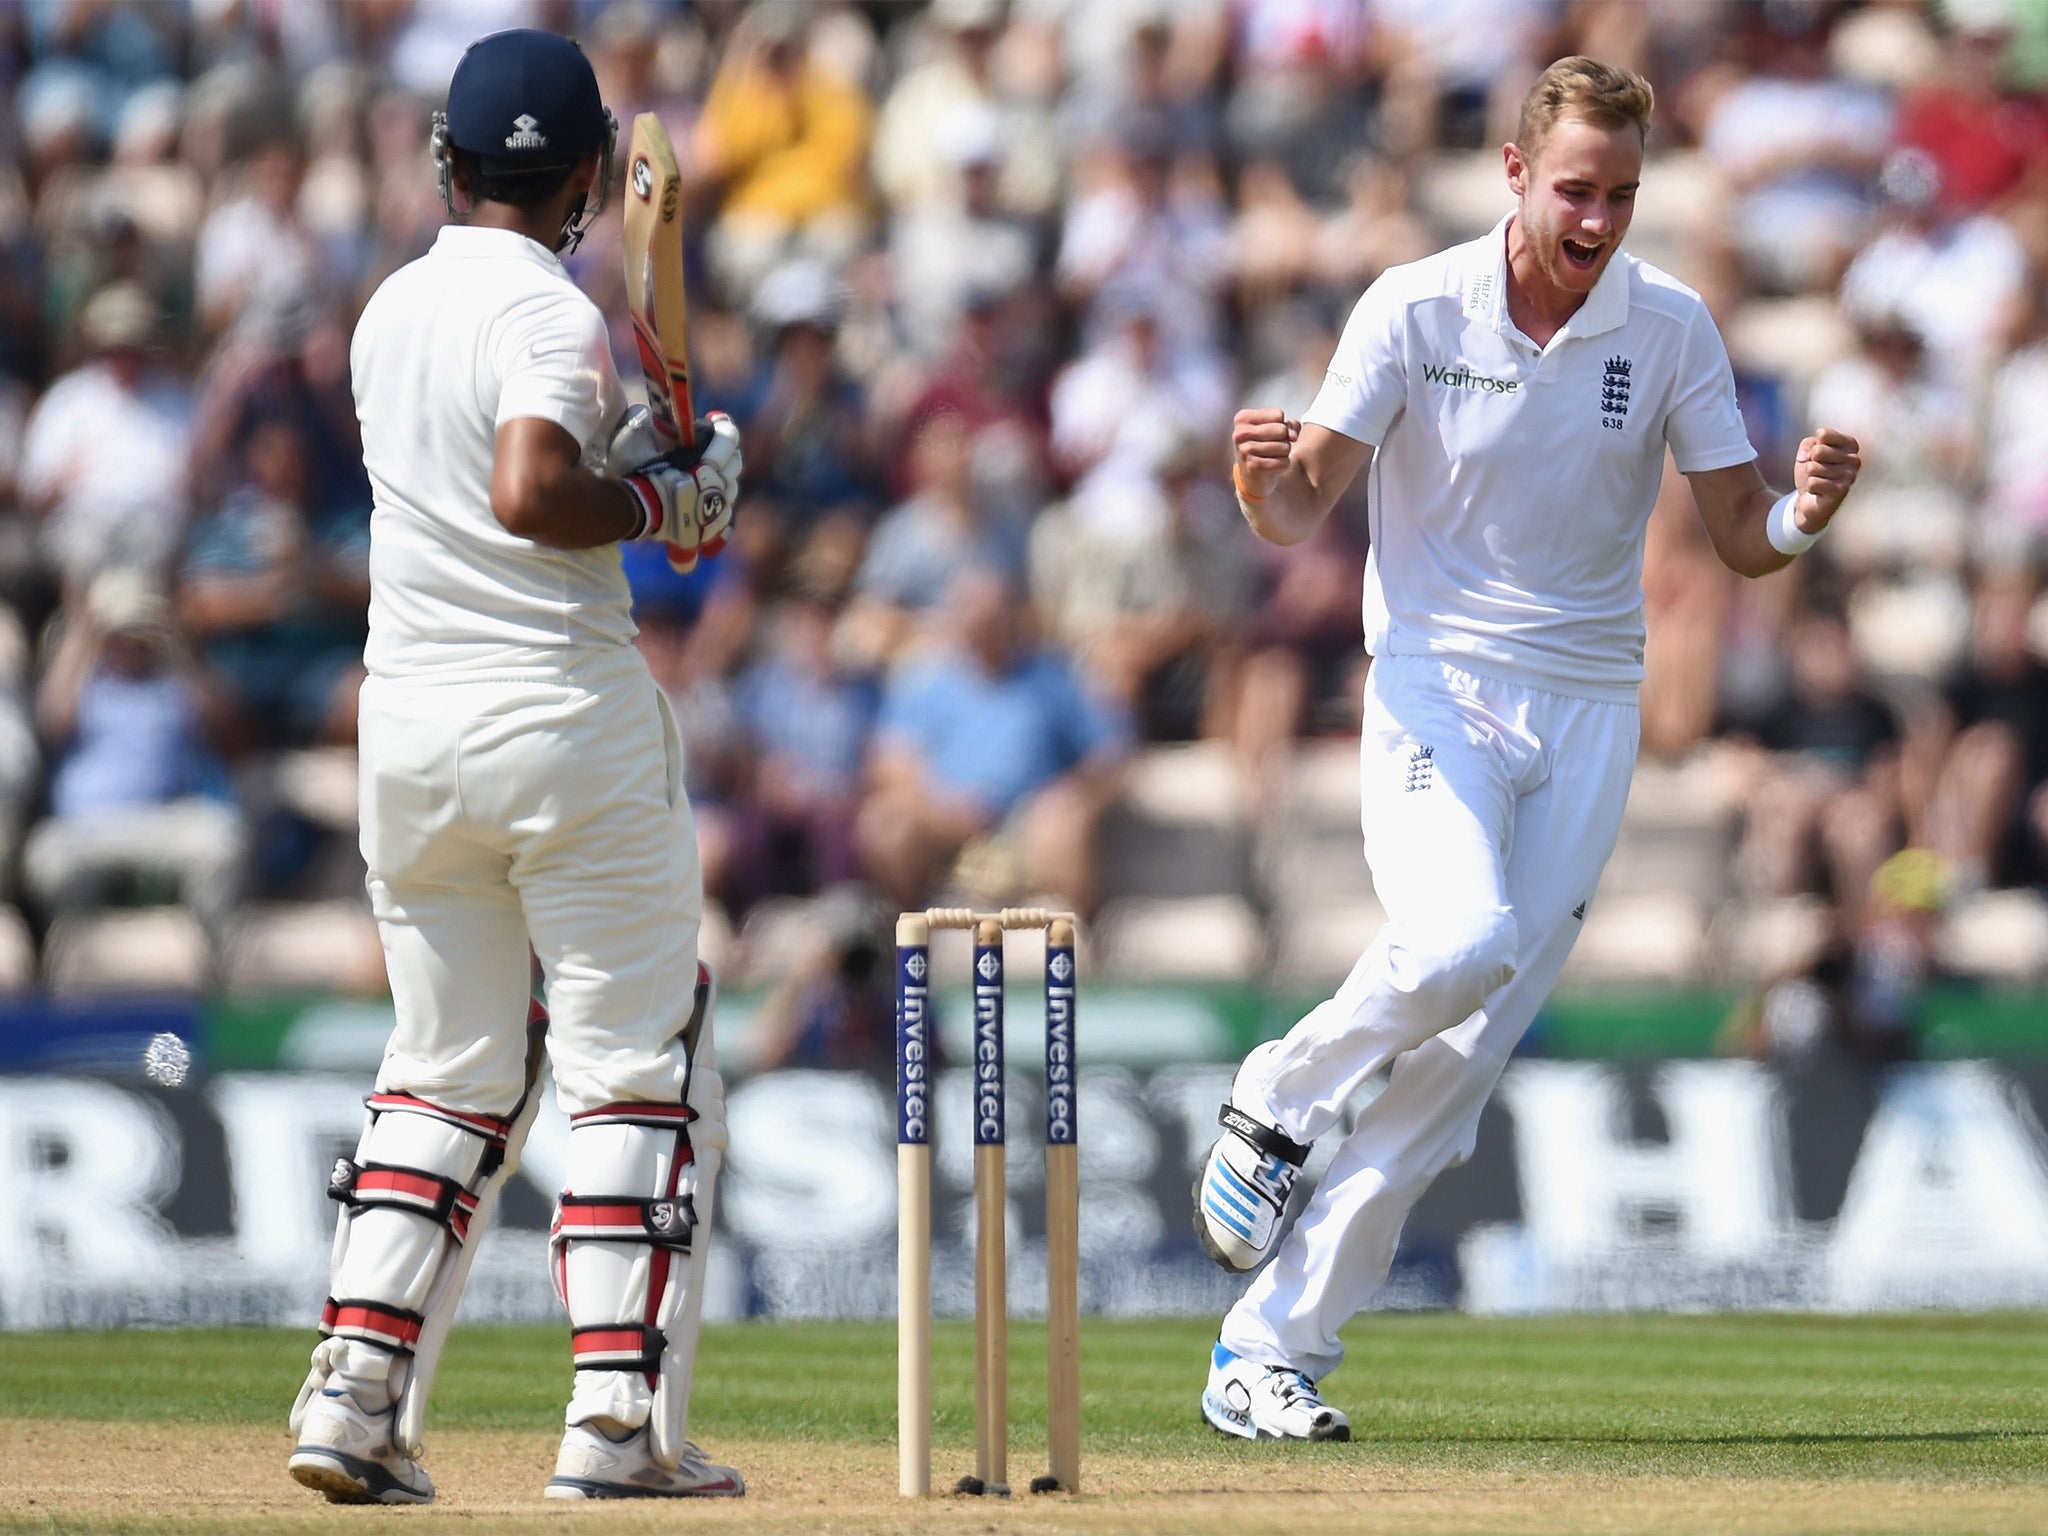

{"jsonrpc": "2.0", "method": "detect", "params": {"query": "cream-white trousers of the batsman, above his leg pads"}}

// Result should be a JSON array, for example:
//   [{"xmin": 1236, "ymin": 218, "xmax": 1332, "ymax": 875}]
[{"xmin": 360, "ymin": 647, "xmax": 702, "ymax": 1116}]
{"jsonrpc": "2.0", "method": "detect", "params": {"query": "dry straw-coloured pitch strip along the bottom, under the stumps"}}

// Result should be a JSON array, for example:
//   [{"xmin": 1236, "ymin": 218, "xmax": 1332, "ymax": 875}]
[{"xmin": 16, "ymin": 1421, "xmax": 2048, "ymax": 1536}]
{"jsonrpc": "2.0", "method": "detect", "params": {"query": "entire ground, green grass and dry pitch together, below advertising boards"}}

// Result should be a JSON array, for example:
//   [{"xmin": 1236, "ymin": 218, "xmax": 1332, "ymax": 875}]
[{"xmin": 0, "ymin": 1315, "xmax": 2048, "ymax": 1536}]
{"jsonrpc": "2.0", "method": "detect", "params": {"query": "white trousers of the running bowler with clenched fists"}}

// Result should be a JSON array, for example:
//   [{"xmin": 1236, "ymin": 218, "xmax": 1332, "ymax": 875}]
[{"xmin": 1221, "ymin": 655, "xmax": 1640, "ymax": 1380}]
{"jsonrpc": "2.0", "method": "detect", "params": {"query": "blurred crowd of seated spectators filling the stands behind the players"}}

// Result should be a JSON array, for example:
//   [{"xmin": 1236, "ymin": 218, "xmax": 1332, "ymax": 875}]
[{"xmin": 0, "ymin": 0, "xmax": 2048, "ymax": 1049}]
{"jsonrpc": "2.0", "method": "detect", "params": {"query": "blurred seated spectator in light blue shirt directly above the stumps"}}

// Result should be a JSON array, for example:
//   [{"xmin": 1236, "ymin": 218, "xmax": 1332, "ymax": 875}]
[{"xmin": 858, "ymin": 567, "xmax": 1128, "ymax": 911}]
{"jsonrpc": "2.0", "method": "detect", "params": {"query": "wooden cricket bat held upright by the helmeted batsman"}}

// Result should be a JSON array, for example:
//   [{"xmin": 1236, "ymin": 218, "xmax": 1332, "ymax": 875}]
[{"xmin": 625, "ymin": 113, "xmax": 696, "ymax": 571}]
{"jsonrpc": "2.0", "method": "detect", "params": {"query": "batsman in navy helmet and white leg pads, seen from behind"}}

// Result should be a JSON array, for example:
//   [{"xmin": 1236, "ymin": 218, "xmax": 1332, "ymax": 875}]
[{"xmin": 291, "ymin": 31, "xmax": 745, "ymax": 1503}]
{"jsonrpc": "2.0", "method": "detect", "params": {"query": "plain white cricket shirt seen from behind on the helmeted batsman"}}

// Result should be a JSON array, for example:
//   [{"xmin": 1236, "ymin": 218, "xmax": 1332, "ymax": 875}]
[{"xmin": 348, "ymin": 225, "xmax": 633, "ymax": 678}]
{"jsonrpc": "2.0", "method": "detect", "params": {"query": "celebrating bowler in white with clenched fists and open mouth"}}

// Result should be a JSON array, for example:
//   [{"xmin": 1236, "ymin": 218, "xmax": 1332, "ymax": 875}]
[{"xmin": 1196, "ymin": 57, "xmax": 1860, "ymax": 1440}]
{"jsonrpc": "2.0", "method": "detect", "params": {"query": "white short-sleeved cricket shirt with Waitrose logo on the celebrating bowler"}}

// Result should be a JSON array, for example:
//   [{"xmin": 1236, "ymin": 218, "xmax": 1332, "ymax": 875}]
[{"xmin": 1303, "ymin": 215, "xmax": 1757, "ymax": 702}]
